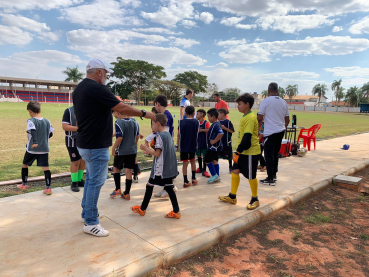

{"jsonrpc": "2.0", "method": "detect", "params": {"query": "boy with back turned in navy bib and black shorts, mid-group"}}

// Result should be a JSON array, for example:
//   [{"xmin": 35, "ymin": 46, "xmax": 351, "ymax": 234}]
[{"xmin": 177, "ymin": 106, "xmax": 200, "ymax": 188}]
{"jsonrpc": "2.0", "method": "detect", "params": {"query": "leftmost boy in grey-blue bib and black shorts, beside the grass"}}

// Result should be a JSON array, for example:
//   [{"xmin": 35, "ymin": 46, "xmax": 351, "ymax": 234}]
[{"xmin": 17, "ymin": 101, "xmax": 54, "ymax": 195}]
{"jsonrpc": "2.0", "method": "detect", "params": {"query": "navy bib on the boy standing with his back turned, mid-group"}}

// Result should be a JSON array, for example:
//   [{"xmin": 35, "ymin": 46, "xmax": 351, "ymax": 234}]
[{"xmin": 178, "ymin": 118, "xmax": 200, "ymax": 152}]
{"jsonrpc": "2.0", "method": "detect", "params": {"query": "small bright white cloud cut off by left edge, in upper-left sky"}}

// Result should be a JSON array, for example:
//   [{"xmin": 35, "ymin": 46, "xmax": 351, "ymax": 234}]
[{"xmin": 0, "ymin": 25, "xmax": 32, "ymax": 46}]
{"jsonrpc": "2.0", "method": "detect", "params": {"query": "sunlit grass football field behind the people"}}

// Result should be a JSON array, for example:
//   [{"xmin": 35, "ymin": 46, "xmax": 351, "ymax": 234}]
[{"xmin": 0, "ymin": 103, "xmax": 369, "ymax": 181}]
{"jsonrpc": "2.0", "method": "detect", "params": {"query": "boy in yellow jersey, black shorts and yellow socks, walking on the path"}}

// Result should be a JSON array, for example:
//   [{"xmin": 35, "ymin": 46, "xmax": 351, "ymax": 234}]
[{"xmin": 219, "ymin": 93, "xmax": 260, "ymax": 210}]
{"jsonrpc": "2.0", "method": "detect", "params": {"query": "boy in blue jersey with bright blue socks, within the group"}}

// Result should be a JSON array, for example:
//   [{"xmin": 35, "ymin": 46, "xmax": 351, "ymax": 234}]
[{"xmin": 205, "ymin": 108, "xmax": 224, "ymax": 184}]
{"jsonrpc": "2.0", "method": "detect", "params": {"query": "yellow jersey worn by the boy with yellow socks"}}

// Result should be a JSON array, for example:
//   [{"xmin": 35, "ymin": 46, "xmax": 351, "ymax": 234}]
[{"xmin": 238, "ymin": 111, "xmax": 261, "ymax": 155}]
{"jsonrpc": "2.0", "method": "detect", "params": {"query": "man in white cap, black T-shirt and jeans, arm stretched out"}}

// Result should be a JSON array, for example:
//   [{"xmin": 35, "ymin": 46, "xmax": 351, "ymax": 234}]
[{"xmin": 73, "ymin": 59, "xmax": 155, "ymax": 237}]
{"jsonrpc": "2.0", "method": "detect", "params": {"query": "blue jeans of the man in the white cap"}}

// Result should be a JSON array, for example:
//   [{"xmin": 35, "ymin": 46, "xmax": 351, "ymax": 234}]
[{"xmin": 78, "ymin": 147, "xmax": 110, "ymax": 225}]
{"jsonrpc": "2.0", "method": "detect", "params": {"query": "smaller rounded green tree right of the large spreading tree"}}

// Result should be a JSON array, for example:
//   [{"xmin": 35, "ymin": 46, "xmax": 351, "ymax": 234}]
[{"xmin": 173, "ymin": 71, "xmax": 209, "ymax": 94}]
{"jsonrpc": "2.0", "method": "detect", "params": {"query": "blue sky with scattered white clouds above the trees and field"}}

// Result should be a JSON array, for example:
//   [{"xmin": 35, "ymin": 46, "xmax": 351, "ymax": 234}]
[{"xmin": 0, "ymin": 0, "xmax": 369, "ymax": 101}]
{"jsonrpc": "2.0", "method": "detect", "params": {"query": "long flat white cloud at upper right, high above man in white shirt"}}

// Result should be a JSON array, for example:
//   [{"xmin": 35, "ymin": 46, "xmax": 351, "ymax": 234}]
[{"xmin": 256, "ymin": 14, "xmax": 335, "ymax": 33}]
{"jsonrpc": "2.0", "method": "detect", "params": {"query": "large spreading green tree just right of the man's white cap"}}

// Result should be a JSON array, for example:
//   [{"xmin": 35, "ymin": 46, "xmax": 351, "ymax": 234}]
[{"xmin": 111, "ymin": 57, "xmax": 167, "ymax": 103}]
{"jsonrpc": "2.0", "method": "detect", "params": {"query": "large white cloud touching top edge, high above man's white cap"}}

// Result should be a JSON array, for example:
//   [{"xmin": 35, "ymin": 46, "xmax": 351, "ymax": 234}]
[{"xmin": 60, "ymin": 0, "xmax": 142, "ymax": 28}]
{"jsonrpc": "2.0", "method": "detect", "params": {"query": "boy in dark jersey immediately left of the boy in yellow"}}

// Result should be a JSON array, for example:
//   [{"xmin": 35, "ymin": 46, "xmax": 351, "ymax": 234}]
[{"xmin": 218, "ymin": 108, "xmax": 234, "ymax": 174}]
